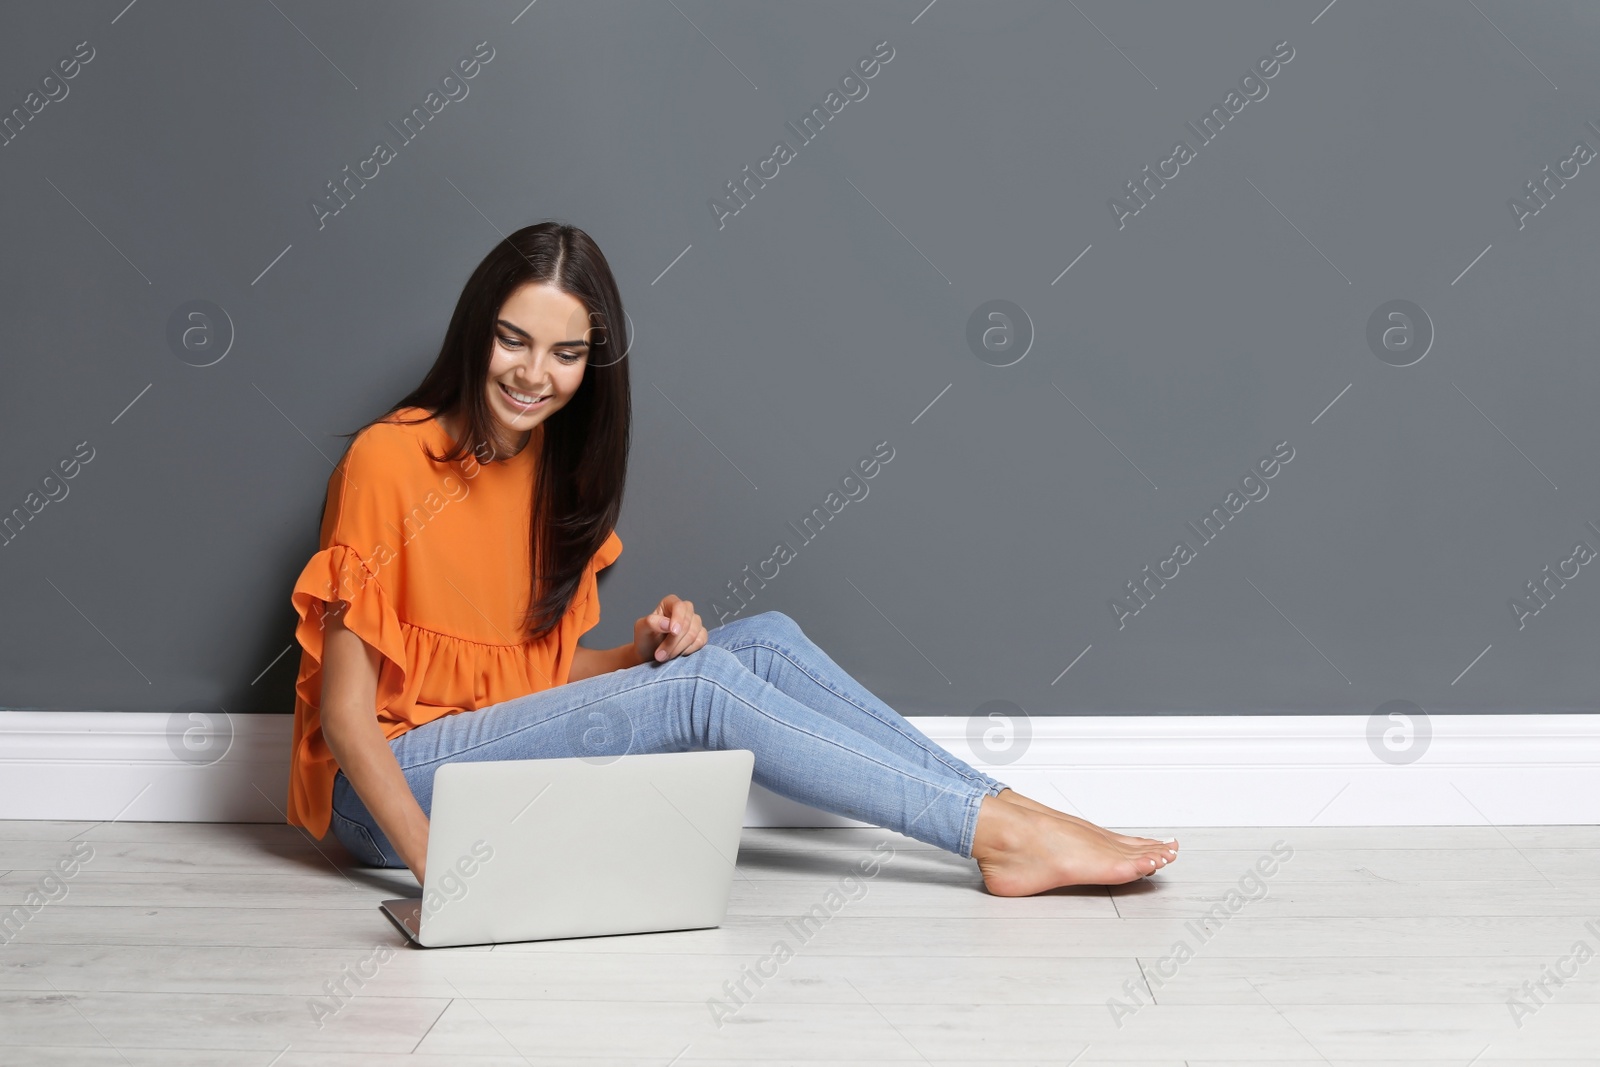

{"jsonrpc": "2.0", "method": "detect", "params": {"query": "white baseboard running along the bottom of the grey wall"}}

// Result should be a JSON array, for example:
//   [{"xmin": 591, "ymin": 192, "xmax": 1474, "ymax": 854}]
[{"xmin": 0, "ymin": 712, "xmax": 1600, "ymax": 829}]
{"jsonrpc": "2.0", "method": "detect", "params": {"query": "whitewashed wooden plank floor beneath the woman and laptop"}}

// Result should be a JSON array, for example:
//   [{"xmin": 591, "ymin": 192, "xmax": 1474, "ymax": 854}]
[{"xmin": 0, "ymin": 822, "xmax": 1600, "ymax": 1067}]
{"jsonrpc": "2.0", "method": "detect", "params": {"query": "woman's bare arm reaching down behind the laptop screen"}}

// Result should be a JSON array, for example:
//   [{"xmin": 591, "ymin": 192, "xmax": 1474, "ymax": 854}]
[{"xmin": 322, "ymin": 609, "xmax": 427, "ymax": 885}]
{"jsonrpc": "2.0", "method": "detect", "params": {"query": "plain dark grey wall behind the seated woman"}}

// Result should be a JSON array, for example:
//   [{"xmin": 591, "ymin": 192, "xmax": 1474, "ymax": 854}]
[{"xmin": 0, "ymin": 0, "xmax": 1600, "ymax": 715}]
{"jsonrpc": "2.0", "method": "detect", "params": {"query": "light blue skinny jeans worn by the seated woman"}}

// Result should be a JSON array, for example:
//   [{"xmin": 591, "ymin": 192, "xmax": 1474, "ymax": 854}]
[{"xmin": 331, "ymin": 611, "xmax": 1005, "ymax": 867}]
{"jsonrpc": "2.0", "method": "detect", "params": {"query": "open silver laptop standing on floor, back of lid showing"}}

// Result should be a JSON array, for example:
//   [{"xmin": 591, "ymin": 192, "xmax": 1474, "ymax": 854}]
[{"xmin": 381, "ymin": 749, "xmax": 755, "ymax": 949}]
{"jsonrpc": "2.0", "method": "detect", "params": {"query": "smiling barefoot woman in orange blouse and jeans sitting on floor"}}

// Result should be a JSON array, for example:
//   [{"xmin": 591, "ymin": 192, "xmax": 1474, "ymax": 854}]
[{"xmin": 288, "ymin": 222, "xmax": 1178, "ymax": 896}]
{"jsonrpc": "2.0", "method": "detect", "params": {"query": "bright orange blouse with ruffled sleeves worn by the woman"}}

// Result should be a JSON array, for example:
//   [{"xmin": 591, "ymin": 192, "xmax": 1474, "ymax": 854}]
[{"xmin": 288, "ymin": 408, "xmax": 622, "ymax": 838}]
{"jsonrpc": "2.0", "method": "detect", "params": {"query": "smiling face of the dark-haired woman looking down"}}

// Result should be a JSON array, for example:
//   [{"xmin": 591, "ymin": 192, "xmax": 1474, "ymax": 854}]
[{"xmin": 486, "ymin": 282, "xmax": 589, "ymax": 456}]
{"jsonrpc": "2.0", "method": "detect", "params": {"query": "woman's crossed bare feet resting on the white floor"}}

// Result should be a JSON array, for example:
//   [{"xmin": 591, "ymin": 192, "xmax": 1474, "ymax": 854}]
[{"xmin": 973, "ymin": 797, "xmax": 1171, "ymax": 896}]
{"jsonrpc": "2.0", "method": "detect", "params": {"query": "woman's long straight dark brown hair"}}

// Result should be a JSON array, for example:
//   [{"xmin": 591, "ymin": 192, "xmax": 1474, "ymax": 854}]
[{"xmin": 331, "ymin": 222, "xmax": 632, "ymax": 640}]
